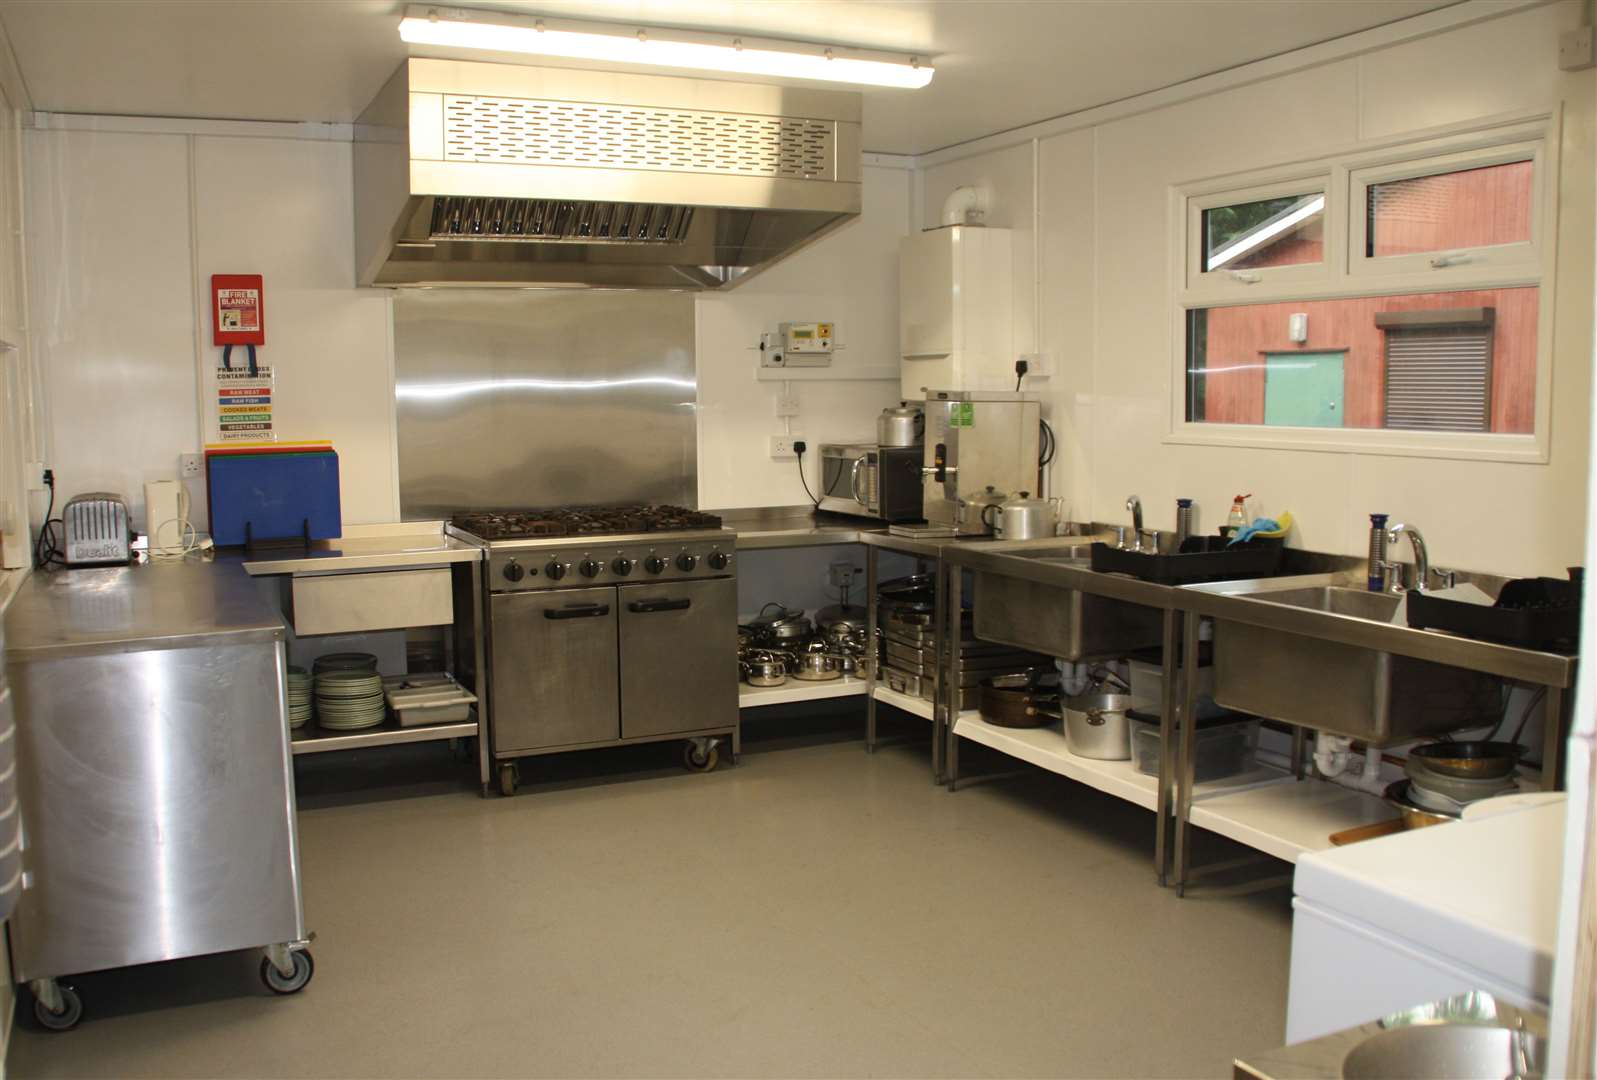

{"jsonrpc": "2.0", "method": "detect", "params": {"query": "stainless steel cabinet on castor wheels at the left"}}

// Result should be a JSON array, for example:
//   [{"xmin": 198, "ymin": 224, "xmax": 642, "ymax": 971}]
[{"xmin": 5, "ymin": 562, "xmax": 313, "ymax": 1029}]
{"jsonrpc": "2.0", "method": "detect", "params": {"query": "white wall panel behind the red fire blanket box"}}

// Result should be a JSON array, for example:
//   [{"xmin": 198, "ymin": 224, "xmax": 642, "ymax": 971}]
[{"xmin": 195, "ymin": 137, "xmax": 399, "ymax": 524}]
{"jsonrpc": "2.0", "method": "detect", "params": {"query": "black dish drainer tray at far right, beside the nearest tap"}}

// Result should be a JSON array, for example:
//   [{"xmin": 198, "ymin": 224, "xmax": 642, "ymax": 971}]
[{"xmin": 1409, "ymin": 567, "xmax": 1581, "ymax": 653}]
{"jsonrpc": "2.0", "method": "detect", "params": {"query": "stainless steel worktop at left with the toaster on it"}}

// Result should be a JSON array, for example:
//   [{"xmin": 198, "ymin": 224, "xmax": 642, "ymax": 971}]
[{"xmin": 5, "ymin": 558, "xmax": 284, "ymax": 663}]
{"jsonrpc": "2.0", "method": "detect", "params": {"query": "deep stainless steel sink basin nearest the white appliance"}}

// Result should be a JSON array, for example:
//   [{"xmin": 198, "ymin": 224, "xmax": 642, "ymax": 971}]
[{"xmin": 1214, "ymin": 578, "xmax": 1503, "ymax": 744}]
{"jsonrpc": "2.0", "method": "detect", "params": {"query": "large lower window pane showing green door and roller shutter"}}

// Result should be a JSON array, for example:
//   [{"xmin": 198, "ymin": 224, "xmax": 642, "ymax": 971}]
[{"xmin": 1187, "ymin": 286, "xmax": 1540, "ymax": 435}]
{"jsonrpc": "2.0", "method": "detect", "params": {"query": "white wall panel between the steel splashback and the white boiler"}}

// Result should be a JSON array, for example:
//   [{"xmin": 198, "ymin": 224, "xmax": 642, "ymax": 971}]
[{"xmin": 698, "ymin": 168, "xmax": 910, "ymax": 508}]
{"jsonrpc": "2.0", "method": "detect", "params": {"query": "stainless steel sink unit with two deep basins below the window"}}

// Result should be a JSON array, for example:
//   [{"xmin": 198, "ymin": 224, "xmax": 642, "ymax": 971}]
[{"xmin": 955, "ymin": 542, "xmax": 1568, "ymax": 744}]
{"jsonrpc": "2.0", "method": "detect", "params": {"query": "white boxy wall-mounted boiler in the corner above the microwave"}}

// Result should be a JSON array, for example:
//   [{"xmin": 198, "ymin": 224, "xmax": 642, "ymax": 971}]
[{"xmin": 899, "ymin": 225, "xmax": 1016, "ymax": 399}]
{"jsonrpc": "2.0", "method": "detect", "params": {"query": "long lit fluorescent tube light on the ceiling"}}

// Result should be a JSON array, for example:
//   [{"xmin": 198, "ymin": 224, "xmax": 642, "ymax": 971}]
[{"xmin": 399, "ymin": 6, "xmax": 933, "ymax": 89}]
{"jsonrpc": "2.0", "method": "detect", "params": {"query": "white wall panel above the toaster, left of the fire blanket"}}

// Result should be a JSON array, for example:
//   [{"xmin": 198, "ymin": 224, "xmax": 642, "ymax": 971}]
[{"xmin": 26, "ymin": 131, "xmax": 203, "ymax": 526}]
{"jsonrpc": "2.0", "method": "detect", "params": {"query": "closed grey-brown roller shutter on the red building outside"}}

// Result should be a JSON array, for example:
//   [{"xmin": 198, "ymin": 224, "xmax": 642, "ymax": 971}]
[{"xmin": 1377, "ymin": 308, "xmax": 1492, "ymax": 431}]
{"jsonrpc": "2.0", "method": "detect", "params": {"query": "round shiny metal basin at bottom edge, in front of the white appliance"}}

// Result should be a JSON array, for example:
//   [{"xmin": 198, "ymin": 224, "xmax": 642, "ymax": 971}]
[{"xmin": 1341, "ymin": 1024, "xmax": 1547, "ymax": 1080}]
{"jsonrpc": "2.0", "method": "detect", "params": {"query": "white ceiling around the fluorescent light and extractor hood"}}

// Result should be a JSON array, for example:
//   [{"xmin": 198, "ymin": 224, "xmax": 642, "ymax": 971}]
[{"xmin": 0, "ymin": 0, "xmax": 1450, "ymax": 153}]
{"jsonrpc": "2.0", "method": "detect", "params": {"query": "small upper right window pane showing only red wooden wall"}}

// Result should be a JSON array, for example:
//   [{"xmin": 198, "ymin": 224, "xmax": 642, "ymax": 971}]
[{"xmin": 1364, "ymin": 161, "xmax": 1535, "ymax": 256}]
